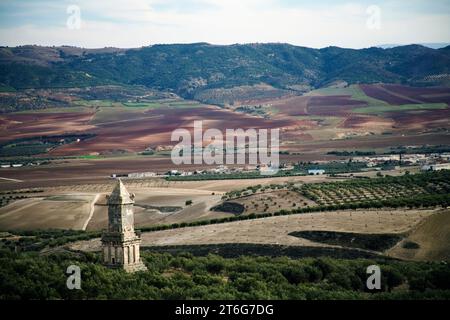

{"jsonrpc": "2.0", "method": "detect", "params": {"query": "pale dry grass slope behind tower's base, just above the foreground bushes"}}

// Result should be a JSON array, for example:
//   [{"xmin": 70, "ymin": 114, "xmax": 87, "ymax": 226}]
[{"xmin": 68, "ymin": 210, "xmax": 435, "ymax": 254}]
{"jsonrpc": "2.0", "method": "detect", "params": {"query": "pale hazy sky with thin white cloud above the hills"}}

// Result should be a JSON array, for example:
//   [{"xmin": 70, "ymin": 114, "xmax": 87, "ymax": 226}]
[{"xmin": 0, "ymin": 0, "xmax": 450, "ymax": 48}]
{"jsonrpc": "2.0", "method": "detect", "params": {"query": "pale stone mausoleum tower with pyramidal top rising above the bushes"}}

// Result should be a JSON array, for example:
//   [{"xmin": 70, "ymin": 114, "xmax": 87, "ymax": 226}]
[{"xmin": 102, "ymin": 179, "xmax": 147, "ymax": 272}]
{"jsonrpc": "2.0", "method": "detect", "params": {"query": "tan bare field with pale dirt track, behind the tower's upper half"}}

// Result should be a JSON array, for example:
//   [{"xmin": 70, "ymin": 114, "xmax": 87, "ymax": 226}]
[{"xmin": 0, "ymin": 186, "xmax": 225, "ymax": 230}]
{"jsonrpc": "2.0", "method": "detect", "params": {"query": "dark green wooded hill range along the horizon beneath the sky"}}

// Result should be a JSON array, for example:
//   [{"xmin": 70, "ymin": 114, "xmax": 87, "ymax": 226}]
[{"xmin": 0, "ymin": 43, "xmax": 450, "ymax": 98}]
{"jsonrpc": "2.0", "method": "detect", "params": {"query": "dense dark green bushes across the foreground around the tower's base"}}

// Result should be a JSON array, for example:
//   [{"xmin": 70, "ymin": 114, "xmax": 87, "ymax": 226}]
[{"xmin": 0, "ymin": 250, "xmax": 450, "ymax": 299}]
